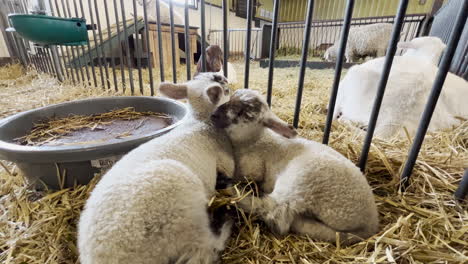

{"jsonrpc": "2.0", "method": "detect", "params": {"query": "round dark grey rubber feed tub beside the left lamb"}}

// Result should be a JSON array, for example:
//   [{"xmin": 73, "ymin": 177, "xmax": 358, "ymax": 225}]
[{"xmin": 0, "ymin": 96, "xmax": 188, "ymax": 190}]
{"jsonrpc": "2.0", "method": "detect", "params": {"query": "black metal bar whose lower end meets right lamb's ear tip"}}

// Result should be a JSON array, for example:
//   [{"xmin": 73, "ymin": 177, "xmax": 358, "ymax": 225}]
[{"xmin": 293, "ymin": 0, "xmax": 314, "ymax": 128}]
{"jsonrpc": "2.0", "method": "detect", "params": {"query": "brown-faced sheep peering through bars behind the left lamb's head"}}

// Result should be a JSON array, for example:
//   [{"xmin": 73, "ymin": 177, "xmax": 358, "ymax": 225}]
[{"xmin": 194, "ymin": 45, "xmax": 237, "ymax": 84}]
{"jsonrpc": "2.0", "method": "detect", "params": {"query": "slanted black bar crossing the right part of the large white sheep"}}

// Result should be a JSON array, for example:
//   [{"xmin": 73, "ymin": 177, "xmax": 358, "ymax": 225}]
[{"xmin": 401, "ymin": 1, "xmax": 468, "ymax": 187}]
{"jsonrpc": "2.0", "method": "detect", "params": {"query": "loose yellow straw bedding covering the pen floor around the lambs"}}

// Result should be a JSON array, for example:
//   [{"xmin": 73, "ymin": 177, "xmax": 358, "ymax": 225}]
[{"xmin": 0, "ymin": 63, "xmax": 468, "ymax": 264}]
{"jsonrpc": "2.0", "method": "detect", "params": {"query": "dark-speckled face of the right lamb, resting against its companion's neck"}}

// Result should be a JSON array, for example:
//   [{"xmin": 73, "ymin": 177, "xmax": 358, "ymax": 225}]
[{"xmin": 211, "ymin": 89, "xmax": 297, "ymax": 142}]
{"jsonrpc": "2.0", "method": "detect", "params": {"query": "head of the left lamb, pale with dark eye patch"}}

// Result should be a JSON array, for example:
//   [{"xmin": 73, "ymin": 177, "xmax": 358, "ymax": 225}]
[{"xmin": 159, "ymin": 72, "xmax": 230, "ymax": 119}]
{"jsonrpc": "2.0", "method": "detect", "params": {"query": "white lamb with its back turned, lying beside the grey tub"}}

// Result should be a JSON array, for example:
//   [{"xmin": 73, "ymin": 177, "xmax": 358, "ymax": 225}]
[{"xmin": 78, "ymin": 73, "xmax": 238, "ymax": 264}]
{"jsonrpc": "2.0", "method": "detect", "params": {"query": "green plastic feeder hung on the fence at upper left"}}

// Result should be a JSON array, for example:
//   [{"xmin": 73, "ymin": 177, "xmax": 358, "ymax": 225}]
[{"xmin": 8, "ymin": 14, "xmax": 89, "ymax": 46}]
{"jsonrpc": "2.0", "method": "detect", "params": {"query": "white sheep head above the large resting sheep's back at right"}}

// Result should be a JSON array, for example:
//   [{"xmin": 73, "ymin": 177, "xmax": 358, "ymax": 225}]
[{"xmin": 398, "ymin": 37, "xmax": 447, "ymax": 66}]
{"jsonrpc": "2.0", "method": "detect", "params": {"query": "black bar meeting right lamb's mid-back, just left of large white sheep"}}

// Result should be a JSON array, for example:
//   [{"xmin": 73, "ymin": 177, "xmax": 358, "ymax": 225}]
[{"xmin": 322, "ymin": 0, "xmax": 354, "ymax": 145}]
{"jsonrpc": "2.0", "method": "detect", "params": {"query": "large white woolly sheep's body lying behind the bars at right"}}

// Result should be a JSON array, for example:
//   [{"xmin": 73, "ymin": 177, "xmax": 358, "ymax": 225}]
[{"xmin": 334, "ymin": 56, "xmax": 468, "ymax": 138}]
